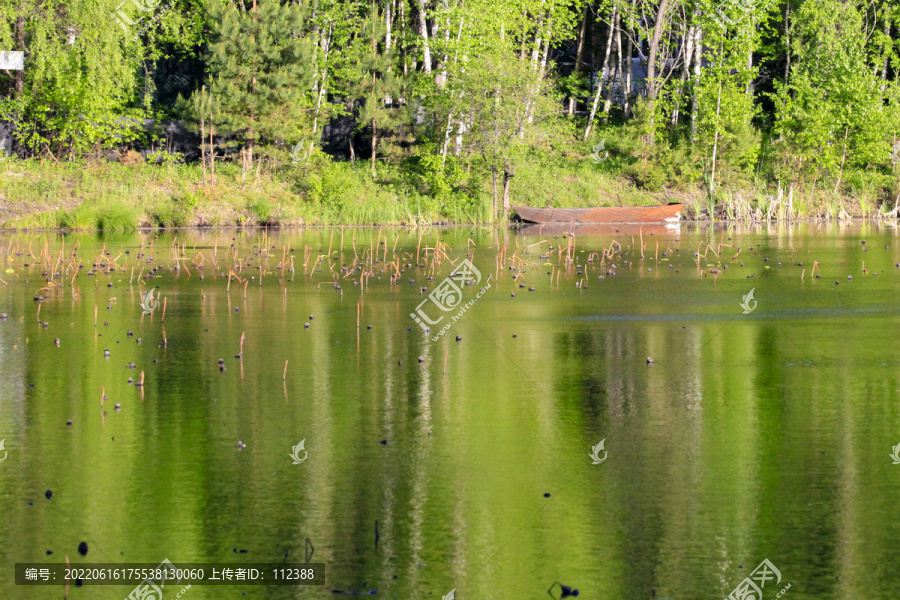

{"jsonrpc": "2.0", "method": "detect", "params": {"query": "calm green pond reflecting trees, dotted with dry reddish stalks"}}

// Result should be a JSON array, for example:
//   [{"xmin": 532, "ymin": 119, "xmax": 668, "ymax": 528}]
[{"xmin": 0, "ymin": 223, "xmax": 900, "ymax": 600}]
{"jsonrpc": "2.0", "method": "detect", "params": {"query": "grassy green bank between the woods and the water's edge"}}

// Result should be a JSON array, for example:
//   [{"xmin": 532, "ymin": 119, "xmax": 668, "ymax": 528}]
[{"xmin": 0, "ymin": 153, "xmax": 893, "ymax": 230}]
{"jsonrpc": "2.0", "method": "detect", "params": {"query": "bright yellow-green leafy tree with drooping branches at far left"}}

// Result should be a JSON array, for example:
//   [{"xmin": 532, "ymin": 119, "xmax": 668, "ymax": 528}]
[{"xmin": 0, "ymin": 0, "xmax": 142, "ymax": 158}]
